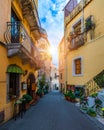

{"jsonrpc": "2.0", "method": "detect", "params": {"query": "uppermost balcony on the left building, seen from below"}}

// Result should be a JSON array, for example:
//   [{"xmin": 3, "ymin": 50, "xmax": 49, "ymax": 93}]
[{"xmin": 18, "ymin": 0, "xmax": 46, "ymax": 40}]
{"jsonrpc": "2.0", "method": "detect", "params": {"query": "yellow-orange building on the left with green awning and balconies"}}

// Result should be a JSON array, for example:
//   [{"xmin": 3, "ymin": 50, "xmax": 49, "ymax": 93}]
[{"xmin": 0, "ymin": 0, "xmax": 46, "ymax": 123}]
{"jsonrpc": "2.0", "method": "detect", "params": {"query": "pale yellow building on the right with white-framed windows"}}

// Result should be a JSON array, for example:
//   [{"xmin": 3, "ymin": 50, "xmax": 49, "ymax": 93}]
[{"xmin": 64, "ymin": 0, "xmax": 104, "ymax": 95}]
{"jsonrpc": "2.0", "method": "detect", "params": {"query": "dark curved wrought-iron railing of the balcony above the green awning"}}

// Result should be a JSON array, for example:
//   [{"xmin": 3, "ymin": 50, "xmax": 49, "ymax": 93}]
[{"xmin": 4, "ymin": 22, "xmax": 41, "ymax": 66}]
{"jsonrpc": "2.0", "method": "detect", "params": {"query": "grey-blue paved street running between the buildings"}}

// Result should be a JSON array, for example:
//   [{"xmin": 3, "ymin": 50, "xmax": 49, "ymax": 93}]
[{"xmin": 0, "ymin": 91, "xmax": 104, "ymax": 130}]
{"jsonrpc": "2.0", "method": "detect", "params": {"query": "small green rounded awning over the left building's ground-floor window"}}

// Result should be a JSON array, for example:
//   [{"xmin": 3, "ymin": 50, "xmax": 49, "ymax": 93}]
[{"xmin": 7, "ymin": 65, "xmax": 24, "ymax": 74}]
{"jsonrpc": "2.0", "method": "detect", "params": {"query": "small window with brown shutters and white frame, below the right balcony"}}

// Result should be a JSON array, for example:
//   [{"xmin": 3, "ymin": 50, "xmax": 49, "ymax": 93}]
[{"xmin": 73, "ymin": 57, "xmax": 82, "ymax": 76}]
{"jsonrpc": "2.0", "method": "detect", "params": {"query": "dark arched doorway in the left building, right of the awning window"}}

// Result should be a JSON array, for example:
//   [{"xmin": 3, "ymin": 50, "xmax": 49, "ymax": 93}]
[{"xmin": 27, "ymin": 73, "xmax": 36, "ymax": 97}]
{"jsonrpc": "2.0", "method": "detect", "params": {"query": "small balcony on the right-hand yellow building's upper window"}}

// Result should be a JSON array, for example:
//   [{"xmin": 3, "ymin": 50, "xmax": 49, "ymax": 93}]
[{"xmin": 69, "ymin": 33, "xmax": 84, "ymax": 50}]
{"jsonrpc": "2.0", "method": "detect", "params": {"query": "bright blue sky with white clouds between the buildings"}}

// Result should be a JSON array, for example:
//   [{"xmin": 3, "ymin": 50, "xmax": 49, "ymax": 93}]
[{"xmin": 38, "ymin": 0, "xmax": 69, "ymax": 65}]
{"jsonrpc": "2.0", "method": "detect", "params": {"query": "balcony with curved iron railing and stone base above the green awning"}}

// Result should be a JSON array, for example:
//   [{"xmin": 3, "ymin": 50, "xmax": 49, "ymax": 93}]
[{"xmin": 4, "ymin": 22, "xmax": 43, "ymax": 68}]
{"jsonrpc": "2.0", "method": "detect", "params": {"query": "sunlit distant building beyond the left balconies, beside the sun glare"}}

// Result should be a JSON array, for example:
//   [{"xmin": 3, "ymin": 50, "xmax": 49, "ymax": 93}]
[{"xmin": 37, "ymin": 38, "xmax": 52, "ymax": 86}]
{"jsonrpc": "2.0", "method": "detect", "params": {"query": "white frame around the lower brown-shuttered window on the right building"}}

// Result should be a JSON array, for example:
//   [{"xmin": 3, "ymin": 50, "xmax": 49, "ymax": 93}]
[{"xmin": 72, "ymin": 56, "xmax": 83, "ymax": 76}]
